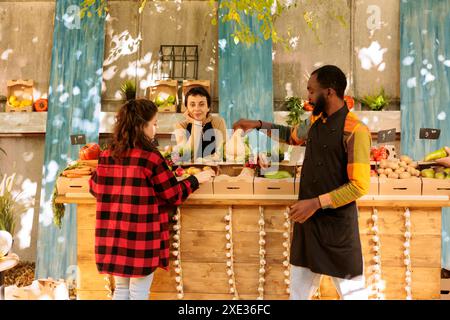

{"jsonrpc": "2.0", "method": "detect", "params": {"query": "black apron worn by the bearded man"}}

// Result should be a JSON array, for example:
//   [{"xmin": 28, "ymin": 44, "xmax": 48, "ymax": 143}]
[{"xmin": 290, "ymin": 105, "xmax": 363, "ymax": 279}]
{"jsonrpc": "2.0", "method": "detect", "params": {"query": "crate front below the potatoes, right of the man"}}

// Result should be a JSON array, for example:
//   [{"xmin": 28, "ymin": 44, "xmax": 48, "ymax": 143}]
[{"xmin": 379, "ymin": 178, "xmax": 422, "ymax": 196}]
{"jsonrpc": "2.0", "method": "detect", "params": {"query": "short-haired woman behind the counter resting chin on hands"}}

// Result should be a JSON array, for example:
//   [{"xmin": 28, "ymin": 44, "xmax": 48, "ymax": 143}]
[{"xmin": 175, "ymin": 87, "xmax": 227, "ymax": 161}]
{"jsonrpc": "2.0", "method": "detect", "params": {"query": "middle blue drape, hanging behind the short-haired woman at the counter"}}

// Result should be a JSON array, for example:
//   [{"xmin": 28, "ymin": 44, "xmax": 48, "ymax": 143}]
[{"xmin": 218, "ymin": 7, "xmax": 273, "ymax": 152}]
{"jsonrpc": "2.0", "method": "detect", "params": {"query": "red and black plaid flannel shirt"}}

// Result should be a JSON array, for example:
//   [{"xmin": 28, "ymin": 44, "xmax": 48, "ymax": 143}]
[{"xmin": 89, "ymin": 149, "xmax": 198, "ymax": 277}]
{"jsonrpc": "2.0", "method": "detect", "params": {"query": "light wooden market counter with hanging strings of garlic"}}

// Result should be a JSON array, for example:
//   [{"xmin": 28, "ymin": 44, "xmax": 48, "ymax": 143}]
[{"xmin": 56, "ymin": 194, "xmax": 450, "ymax": 299}]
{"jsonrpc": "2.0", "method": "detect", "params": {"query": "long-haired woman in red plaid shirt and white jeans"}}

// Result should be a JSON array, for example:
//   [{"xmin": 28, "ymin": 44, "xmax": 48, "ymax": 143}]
[{"xmin": 90, "ymin": 99, "xmax": 212, "ymax": 300}]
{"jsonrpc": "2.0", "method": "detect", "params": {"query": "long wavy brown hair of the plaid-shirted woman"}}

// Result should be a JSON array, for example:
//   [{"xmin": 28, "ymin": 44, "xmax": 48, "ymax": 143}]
[{"xmin": 110, "ymin": 99, "xmax": 158, "ymax": 158}]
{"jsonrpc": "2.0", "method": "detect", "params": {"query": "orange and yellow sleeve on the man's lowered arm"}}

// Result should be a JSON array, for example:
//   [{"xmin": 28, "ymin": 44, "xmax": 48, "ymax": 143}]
[{"xmin": 319, "ymin": 112, "xmax": 372, "ymax": 209}]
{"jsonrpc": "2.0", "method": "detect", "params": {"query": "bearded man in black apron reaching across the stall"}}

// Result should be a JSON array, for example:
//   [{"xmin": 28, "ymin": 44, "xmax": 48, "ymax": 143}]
[{"xmin": 233, "ymin": 65, "xmax": 371, "ymax": 300}]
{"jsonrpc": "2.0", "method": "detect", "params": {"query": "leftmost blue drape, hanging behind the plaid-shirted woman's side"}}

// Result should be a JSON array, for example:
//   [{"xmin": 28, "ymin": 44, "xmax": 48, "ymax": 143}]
[{"xmin": 36, "ymin": 0, "xmax": 105, "ymax": 278}]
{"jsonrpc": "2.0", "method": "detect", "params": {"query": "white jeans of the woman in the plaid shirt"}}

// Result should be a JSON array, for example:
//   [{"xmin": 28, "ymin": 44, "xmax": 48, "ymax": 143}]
[{"xmin": 113, "ymin": 272, "xmax": 154, "ymax": 300}]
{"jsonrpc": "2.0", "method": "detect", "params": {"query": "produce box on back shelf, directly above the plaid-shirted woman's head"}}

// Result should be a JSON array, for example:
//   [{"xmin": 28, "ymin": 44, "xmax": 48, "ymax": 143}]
[{"xmin": 147, "ymin": 80, "xmax": 178, "ymax": 112}]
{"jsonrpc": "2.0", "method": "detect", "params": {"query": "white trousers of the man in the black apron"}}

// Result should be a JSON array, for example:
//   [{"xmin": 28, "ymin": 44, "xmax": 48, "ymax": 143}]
[{"xmin": 289, "ymin": 264, "xmax": 368, "ymax": 300}]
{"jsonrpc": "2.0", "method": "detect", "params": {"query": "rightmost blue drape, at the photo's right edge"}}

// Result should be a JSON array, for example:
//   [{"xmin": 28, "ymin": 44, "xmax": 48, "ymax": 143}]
[{"xmin": 400, "ymin": 0, "xmax": 450, "ymax": 269}]
